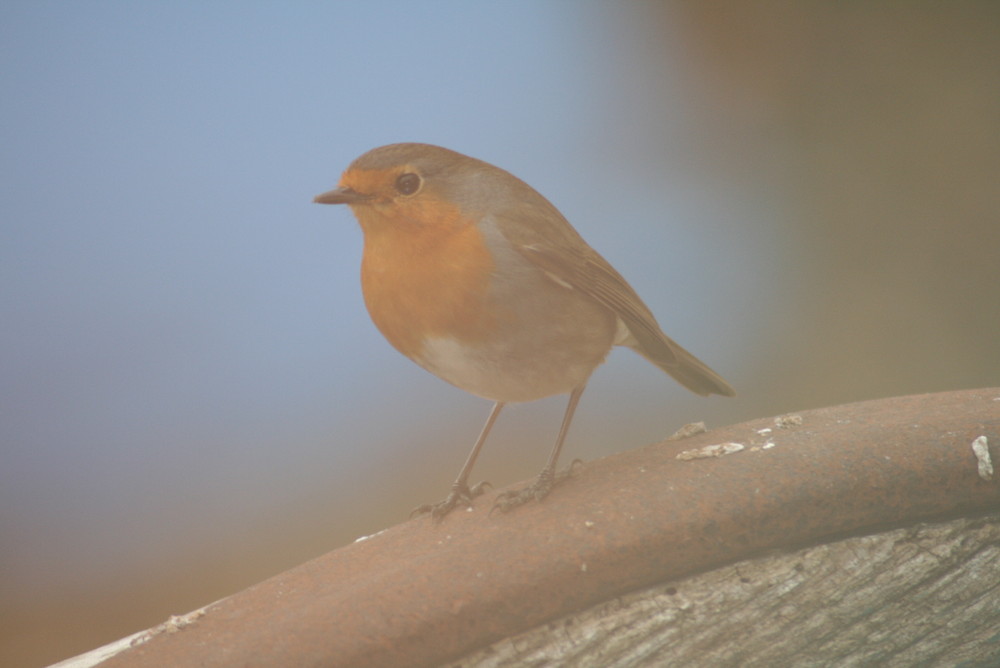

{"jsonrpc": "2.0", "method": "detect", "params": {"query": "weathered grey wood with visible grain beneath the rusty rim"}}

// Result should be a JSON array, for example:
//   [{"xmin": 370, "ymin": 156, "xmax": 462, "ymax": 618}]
[{"xmin": 449, "ymin": 515, "xmax": 1000, "ymax": 668}]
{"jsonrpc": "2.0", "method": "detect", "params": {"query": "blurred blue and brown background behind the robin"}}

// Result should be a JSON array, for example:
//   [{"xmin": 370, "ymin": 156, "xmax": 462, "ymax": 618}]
[{"xmin": 0, "ymin": 0, "xmax": 1000, "ymax": 666}]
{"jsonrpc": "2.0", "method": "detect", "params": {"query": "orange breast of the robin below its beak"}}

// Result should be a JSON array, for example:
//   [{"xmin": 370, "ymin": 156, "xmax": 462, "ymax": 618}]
[{"xmin": 355, "ymin": 200, "xmax": 496, "ymax": 358}]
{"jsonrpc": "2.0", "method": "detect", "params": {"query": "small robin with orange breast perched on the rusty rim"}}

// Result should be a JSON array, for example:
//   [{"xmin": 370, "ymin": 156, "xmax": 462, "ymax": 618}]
[{"xmin": 314, "ymin": 144, "xmax": 734, "ymax": 519}]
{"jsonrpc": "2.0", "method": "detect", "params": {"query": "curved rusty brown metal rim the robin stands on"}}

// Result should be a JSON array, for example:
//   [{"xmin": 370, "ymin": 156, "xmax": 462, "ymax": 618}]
[{"xmin": 100, "ymin": 388, "xmax": 1000, "ymax": 667}]
